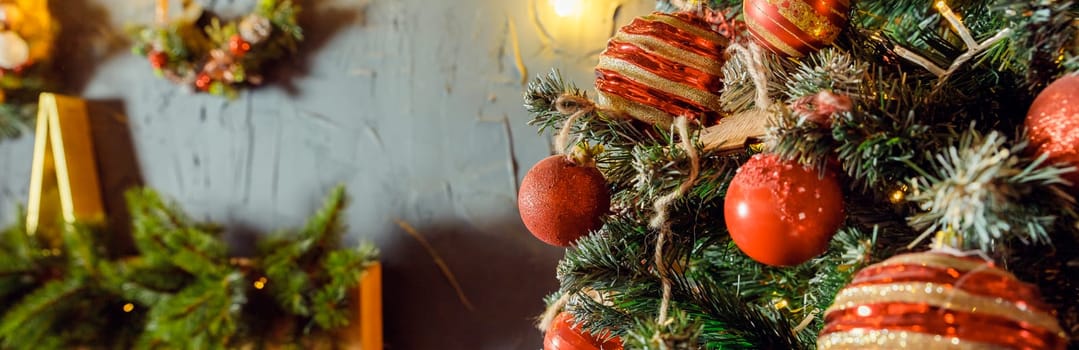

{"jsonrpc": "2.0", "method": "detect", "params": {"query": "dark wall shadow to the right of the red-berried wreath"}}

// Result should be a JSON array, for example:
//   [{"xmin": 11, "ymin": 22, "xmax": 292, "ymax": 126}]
[{"xmin": 264, "ymin": 0, "xmax": 368, "ymax": 96}]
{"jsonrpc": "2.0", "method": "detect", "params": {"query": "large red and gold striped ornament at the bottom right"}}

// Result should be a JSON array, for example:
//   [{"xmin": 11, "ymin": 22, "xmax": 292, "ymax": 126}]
[{"xmin": 817, "ymin": 252, "xmax": 1068, "ymax": 350}]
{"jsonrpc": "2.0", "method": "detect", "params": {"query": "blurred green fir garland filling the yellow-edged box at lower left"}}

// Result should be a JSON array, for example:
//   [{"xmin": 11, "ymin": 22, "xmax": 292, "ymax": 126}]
[{"xmin": 0, "ymin": 187, "xmax": 378, "ymax": 349}]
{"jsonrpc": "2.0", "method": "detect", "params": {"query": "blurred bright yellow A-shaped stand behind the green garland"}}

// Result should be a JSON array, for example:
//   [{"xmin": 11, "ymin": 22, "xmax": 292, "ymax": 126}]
[{"xmin": 26, "ymin": 93, "xmax": 105, "ymax": 234}]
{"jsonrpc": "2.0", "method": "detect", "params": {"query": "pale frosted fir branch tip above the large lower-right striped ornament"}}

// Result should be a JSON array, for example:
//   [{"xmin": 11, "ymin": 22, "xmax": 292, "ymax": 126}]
[{"xmin": 910, "ymin": 130, "xmax": 1076, "ymax": 250}]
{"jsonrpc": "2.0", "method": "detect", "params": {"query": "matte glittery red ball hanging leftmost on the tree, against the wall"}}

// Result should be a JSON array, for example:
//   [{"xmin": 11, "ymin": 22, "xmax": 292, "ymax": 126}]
[{"xmin": 517, "ymin": 156, "xmax": 611, "ymax": 246}]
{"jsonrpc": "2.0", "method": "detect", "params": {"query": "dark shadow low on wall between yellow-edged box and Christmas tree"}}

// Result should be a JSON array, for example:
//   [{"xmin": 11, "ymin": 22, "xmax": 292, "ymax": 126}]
[{"xmin": 381, "ymin": 217, "xmax": 563, "ymax": 350}]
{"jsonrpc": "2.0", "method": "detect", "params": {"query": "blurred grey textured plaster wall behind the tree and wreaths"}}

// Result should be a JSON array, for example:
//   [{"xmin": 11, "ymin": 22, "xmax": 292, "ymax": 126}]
[{"xmin": 0, "ymin": 0, "xmax": 652, "ymax": 349}]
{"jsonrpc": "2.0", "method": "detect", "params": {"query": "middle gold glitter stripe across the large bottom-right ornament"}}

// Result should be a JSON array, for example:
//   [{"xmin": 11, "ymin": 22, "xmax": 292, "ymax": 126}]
[{"xmin": 824, "ymin": 282, "xmax": 1064, "ymax": 334}]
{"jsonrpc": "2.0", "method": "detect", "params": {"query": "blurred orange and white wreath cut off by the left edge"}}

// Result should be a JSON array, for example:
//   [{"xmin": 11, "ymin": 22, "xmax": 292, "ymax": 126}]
[{"xmin": 0, "ymin": 0, "xmax": 57, "ymax": 138}]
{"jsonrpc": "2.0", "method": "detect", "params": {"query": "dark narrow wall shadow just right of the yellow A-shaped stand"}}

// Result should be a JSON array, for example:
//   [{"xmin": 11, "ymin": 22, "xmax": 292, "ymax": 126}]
[{"xmin": 86, "ymin": 99, "xmax": 142, "ymax": 256}]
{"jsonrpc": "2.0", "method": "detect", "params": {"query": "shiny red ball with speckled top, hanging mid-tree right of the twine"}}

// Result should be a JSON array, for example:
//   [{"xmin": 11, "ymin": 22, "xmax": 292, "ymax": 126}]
[{"xmin": 723, "ymin": 154, "xmax": 844, "ymax": 266}]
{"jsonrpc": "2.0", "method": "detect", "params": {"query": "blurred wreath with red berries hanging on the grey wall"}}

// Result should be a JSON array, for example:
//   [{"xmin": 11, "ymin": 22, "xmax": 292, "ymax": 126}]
[{"xmin": 133, "ymin": 0, "xmax": 303, "ymax": 98}]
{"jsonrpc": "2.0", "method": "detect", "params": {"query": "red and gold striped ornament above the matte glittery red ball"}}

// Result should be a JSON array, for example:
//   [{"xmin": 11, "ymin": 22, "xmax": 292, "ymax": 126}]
[{"xmin": 596, "ymin": 13, "xmax": 727, "ymax": 125}]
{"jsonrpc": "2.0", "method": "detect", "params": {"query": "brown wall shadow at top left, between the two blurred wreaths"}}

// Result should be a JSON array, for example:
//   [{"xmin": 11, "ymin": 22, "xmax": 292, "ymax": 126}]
[{"xmin": 49, "ymin": 0, "xmax": 129, "ymax": 95}]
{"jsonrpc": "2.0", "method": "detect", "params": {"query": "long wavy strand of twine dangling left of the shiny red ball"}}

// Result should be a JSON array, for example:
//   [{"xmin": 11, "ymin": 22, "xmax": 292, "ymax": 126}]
[{"xmin": 648, "ymin": 117, "xmax": 700, "ymax": 344}]
